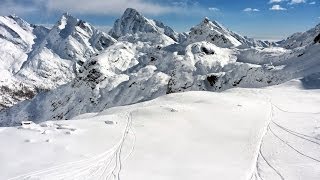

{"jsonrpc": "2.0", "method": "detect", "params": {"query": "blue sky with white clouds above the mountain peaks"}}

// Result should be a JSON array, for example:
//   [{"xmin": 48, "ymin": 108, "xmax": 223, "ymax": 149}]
[{"xmin": 0, "ymin": 0, "xmax": 320, "ymax": 39}]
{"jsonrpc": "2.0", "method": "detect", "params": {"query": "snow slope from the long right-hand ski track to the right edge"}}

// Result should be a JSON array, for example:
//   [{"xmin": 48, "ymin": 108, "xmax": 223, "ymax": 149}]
[{"xmin": 253, "ymin": 80, "xmax": 320, "ymax": 179}]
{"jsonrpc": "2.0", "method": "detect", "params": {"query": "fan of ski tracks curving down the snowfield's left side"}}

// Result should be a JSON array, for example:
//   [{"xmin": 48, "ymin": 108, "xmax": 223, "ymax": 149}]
[{"xmin": 9, "ymin": 113, "xmax": 136, "ymax": 180}]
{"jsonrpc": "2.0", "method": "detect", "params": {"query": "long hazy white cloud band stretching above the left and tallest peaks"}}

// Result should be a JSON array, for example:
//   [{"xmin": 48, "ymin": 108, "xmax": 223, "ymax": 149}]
[{"xmin": 0, "ymin": 0, "xmax": 208, "ymax": 16}]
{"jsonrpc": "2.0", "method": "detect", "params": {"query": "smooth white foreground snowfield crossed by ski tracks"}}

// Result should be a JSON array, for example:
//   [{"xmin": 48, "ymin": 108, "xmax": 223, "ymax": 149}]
[{"xmin": 0, "ymin": 79, "xmax": 320, "ymax": 180}]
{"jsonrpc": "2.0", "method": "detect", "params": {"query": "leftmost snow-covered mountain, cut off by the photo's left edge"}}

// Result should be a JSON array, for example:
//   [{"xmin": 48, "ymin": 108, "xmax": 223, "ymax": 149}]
[{"xmin": 0, "ymin": 16, "xmax": 49, "ymax": 109}]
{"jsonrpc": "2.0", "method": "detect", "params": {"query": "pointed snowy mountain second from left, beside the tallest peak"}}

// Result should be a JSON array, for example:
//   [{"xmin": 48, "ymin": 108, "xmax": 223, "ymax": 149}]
[{"xmin": 17, "ymin": 14, "xmax": 116, "ymax": 89}]
